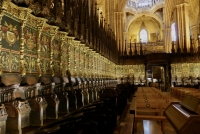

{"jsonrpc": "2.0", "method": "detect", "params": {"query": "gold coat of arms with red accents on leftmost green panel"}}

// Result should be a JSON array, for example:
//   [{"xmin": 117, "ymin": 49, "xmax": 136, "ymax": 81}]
[{"xmin": 1, "ymin": 21, "xmax": 19, "ymax": 46}]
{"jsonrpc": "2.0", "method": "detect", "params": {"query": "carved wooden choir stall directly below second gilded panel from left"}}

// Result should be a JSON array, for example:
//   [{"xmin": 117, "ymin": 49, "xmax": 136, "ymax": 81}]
[{"xmin": 20, "ymin": 75, "xmax": 47, "ymax": 126}]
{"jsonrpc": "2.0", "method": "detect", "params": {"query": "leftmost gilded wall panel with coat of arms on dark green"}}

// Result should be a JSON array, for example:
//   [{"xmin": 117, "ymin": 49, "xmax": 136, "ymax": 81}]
[{"xmin": 1, "ymin": 15, "xmax": 20, "ymax": 72}]
